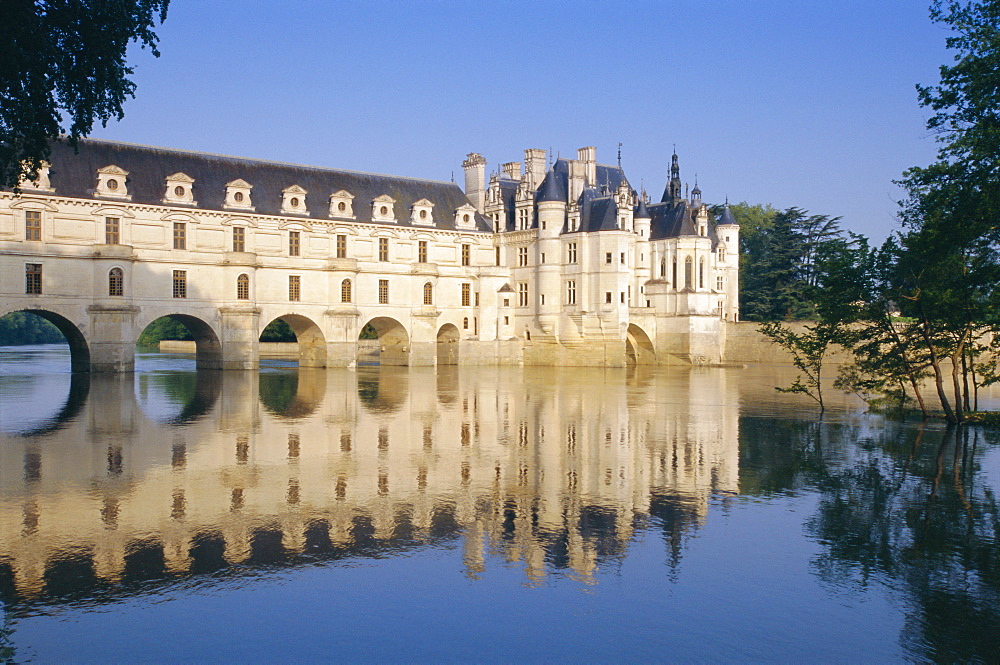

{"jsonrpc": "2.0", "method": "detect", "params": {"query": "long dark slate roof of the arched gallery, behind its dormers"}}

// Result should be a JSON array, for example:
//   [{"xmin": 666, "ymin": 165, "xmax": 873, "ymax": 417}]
[{"xmin": 19, "ymin": 139, "xmax": 490, "ymax": 231}]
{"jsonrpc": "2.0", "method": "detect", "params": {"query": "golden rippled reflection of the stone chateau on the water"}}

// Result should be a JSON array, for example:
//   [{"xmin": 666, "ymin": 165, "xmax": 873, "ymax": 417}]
[{"xmin": 0, "ymin": 367, "xmax": 739, "ymax": 603}]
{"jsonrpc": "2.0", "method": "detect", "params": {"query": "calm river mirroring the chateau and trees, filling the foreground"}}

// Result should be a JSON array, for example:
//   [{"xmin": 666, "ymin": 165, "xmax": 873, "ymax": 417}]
[{"xmin": 0, "ymin": 346, "xmax": 1000, "ymax": 663}]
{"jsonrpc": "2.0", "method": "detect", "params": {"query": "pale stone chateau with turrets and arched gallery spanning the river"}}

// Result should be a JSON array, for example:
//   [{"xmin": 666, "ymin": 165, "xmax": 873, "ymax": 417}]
[{"xmin": 0, "ymin": 140, "xmax": 739, "ymax": 371}]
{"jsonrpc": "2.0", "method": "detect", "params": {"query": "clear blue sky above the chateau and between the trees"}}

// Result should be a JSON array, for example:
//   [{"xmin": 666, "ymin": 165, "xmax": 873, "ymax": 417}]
[{"xmin": 93, "ymin": 0, "xmax": 951, "ymax": 238}]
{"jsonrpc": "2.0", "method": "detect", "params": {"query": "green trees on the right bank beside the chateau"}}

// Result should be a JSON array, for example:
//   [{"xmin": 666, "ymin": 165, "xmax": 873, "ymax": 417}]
[{"xmin": 733, "ymin": 0, "xmax": 1000, "ymax": 423}]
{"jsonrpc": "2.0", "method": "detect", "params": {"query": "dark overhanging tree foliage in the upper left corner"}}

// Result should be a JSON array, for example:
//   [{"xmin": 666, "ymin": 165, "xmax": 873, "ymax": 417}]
[{"xmin": 0, "ymin": 0, "xmax": 170, "ymax": 187}]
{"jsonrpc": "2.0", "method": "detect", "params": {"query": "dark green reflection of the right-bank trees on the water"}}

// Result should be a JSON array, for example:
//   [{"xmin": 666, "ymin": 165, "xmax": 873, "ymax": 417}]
[{"xmin": 807, "ymin": 422, "xmax": 1000, "ymax": 662}]
